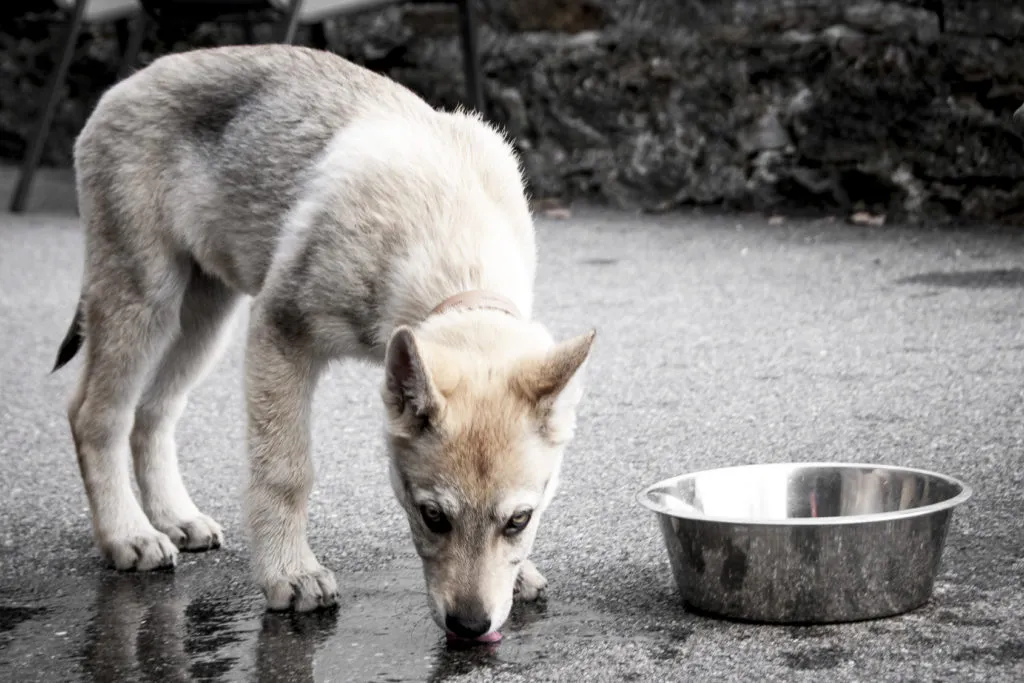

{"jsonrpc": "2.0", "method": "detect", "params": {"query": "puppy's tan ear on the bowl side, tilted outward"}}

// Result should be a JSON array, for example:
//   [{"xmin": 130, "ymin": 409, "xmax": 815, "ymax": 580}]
[{"xmin": 516, "ymin": 330, "xmax": 597, "ymax": 444}]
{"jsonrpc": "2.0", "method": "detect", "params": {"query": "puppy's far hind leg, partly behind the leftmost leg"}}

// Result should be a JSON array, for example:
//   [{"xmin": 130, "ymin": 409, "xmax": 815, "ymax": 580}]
[{"xmin": 131, "ymin": 265, "xmax": 240, "ymax": 551}]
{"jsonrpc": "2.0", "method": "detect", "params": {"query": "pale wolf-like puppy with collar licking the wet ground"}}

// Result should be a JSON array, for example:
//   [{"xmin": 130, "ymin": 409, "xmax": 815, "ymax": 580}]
[{"xmin": 54, "ymin": 45, "xmax": 596, "ymax": 639}]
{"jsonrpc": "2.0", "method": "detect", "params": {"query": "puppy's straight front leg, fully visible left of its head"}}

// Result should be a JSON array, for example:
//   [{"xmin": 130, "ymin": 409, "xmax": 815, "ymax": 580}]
[{"xmin": 240, "ymin": 304, "xmax": 338, "ymax": 611}]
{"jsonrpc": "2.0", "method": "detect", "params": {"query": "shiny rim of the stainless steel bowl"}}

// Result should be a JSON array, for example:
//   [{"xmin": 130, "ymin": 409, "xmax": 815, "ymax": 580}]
[{"xmin": 636, "ymin": 461, "xmax": 974, "ymax": 526}]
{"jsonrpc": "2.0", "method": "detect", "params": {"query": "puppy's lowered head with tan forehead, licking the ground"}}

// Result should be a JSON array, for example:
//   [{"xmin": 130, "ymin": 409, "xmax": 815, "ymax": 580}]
[{"xmin": 382, "ymin": 328, "xmax": 594, "ymax": 638}]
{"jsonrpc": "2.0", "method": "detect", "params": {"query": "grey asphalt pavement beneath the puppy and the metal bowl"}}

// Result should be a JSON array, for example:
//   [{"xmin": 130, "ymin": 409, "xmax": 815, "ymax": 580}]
[{"xmin": 0, "ymin": 174, "xmax": 1024, "ymax": 683}]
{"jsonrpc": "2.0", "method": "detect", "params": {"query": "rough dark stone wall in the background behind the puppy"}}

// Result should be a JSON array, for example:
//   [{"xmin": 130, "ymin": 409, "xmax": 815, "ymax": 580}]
[{"xmin": 0, "ymin": 0, "xmax": 1024, "ymax": 224}]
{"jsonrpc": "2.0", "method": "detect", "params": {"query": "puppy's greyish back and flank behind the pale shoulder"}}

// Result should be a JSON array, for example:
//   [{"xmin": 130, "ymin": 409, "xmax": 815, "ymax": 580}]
[{"xmin": 75, "ymin": 46, "xmax": 419, "ymax": 294}]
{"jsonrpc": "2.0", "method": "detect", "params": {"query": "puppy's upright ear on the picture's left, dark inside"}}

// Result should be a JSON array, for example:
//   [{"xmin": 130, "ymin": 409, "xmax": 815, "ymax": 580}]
[{"xmin": 382, "ymin": 326, "xmax": 443, "ymax": 435}]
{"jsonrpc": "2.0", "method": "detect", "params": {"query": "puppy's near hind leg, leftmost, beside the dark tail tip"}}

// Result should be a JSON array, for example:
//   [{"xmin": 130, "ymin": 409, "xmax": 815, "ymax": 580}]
[{"xmin": 68, "ymin": 201, "xmax": 188, "ymax": 570}]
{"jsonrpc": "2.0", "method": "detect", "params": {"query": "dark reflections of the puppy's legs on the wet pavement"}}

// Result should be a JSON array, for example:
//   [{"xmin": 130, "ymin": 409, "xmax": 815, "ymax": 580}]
[{"xmin": 82, "ymin": 573, "xmax": 337, "ymax": 682}]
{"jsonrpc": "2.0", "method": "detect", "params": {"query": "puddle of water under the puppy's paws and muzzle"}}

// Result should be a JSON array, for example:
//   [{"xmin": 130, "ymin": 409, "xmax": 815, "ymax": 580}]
[{"xmin": 0, "ymin": 565, "xmax": 644, "ymax": 683}]
